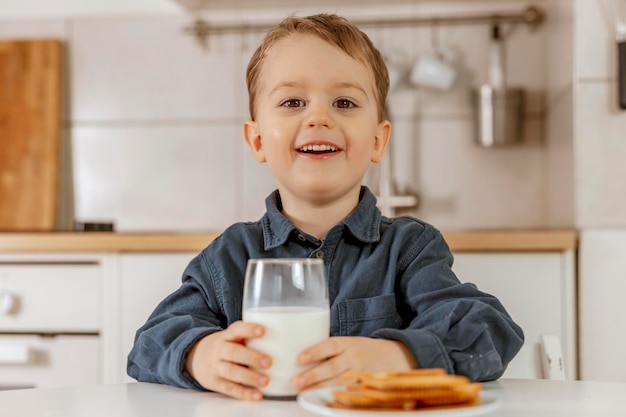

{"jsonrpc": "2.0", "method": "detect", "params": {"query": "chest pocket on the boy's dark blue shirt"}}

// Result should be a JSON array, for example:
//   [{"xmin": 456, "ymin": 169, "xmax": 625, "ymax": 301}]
[{"xmin": 338, "ymin": 294, "xmax": 402, "ymax": 336}]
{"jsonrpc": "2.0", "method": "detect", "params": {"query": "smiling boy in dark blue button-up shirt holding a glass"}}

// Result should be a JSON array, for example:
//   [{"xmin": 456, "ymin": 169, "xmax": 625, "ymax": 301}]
[{"xmin": 128, "ymin": 14, "xmax": 523, "ymax": 400}]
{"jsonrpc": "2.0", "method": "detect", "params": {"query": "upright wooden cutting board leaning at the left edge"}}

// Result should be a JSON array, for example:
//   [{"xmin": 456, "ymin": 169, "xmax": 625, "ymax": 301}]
[{"xmin": 0, "ymin": 40, "xmax": 63, "ymax": 231}]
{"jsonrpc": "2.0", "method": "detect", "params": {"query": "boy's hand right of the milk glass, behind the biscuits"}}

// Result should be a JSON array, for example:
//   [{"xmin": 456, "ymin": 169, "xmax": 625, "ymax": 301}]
[{"xmin": 294, "ymin": 336, "xmax": 417, "ymax": 390}]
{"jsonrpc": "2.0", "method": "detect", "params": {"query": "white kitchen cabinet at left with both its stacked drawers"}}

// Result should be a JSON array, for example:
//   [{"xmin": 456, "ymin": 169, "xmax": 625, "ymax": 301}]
[{"xmin": 0, "ymin": 254, "xmax": 103, "ymax": 389}]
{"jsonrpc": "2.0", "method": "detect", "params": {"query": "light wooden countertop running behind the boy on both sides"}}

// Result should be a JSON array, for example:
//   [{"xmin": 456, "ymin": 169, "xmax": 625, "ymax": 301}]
[{"xmin": 0, "ymin": 229, "xmax": 578, "ymax": 253}]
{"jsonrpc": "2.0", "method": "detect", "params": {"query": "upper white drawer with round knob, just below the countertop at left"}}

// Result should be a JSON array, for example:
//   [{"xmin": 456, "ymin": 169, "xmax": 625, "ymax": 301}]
[{"xmin": 0, "ymin": 263, "xmax": 100, "ymax": 333}]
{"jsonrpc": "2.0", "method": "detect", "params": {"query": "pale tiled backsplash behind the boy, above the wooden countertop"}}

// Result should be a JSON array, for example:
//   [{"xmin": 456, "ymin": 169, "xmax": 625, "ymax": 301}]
[{"xmin": 0, "ymin": 1, "xmax": 569, "ymax": 231}]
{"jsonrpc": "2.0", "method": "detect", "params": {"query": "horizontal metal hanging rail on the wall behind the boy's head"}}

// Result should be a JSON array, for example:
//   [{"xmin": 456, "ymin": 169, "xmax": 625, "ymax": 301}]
[{"xmin": 184, "ymin": 6, "xmax": 545, "ymax": 48}]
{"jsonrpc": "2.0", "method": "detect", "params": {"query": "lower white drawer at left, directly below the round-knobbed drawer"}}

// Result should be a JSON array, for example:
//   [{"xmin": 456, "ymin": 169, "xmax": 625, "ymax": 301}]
[{"xmin": 0, "ymin": 335, "xmax": 100, "ymax": 388}]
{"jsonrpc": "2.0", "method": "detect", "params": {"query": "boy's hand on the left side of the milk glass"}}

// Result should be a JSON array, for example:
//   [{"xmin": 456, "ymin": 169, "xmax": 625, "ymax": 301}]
[{"xmin": 185, "ymin": 321, "xmax": 272, "ymax": 400}]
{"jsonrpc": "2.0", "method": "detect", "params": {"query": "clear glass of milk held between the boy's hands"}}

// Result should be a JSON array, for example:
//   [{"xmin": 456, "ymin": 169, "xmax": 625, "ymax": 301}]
[{"xmin": 243, "ymin": 258, "xmax": 330, "ymax": 399}]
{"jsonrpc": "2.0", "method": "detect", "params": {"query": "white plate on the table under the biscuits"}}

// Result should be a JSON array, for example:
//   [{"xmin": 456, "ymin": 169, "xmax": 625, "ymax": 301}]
[{"xmin": 298, "ymin": 387, "xmax": 500, "ymax": 417}]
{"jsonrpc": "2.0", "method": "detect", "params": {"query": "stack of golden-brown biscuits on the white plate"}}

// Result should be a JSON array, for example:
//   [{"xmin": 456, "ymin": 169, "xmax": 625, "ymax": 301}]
[{"xmin": 328, "ymin": 368, "xmax": 481, "ymax": 410}]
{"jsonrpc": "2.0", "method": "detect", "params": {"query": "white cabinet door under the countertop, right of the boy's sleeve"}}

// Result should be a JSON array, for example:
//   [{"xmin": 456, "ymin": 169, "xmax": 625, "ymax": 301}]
[{"xmin": 453, "ymin": 253, "xmax": 576, "ymax": 379}]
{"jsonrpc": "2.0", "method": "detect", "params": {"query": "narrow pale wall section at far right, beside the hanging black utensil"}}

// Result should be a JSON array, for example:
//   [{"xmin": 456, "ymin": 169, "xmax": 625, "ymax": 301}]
[{"xmin": 574, "ymin": 0, "xmax": 626, "ymax": 228}]
